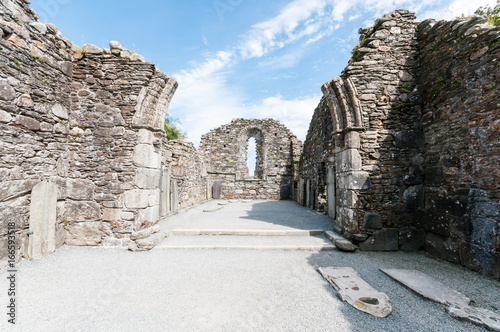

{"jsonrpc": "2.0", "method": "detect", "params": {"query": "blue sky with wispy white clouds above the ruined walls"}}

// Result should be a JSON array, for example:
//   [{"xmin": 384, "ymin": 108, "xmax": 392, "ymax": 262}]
[{"xmin": 31, "ymin": 0, "xmax": 495, "ymax": 146}]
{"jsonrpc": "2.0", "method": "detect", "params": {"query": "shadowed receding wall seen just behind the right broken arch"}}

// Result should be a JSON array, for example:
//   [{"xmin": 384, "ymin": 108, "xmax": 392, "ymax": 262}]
[{"xmin": 295, "ymin": 98, "xmax": 335, "ymax": 213}]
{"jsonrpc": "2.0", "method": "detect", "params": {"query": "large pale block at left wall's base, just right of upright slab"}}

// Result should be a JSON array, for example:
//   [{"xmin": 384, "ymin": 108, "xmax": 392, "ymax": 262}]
[{"xmin": 66, "ymin": 222, "xmax": 112, "ymax": 246}]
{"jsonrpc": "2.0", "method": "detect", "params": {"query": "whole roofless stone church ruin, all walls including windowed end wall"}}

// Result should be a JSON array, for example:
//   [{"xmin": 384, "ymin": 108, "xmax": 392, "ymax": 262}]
[{"xmin": 0, "ymin": 0, "xmax": 500, "ymax": 278}]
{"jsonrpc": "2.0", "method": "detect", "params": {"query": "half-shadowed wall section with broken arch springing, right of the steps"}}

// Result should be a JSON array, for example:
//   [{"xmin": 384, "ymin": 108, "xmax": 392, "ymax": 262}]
[{"xmin": 322, "ymin": 10, "xmax": 424, "ymax": 250}]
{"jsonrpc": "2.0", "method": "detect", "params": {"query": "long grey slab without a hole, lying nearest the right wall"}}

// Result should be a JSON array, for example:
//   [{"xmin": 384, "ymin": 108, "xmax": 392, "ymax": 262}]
[{"xmin": 381, "ymin": 269, "xmax": 500, "ymax": 332}]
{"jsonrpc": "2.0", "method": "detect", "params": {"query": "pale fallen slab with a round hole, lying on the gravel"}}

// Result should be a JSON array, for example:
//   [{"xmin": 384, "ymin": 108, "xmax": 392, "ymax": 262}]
[{"xmin": 318, "ymin": 267, "xmax": 392, "ymax": 318}]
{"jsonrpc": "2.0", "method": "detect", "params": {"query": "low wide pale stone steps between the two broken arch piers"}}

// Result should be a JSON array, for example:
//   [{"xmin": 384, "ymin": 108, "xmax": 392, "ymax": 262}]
[{"xmin": 155, "ymin": 231, "xmax": 336, "ymax": 251}]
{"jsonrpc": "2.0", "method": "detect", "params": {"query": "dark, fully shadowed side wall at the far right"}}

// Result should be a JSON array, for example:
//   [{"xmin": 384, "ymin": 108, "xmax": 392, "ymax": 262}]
[{"xmin": 419, "ymin": 17, "xmax": 500, "ymax": 278}]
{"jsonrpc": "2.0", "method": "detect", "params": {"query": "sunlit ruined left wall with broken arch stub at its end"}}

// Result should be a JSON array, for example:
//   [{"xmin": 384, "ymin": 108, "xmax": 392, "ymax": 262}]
[{"xmin": 0, "ymin": 0, "xmax": 186, "ymax": 260}]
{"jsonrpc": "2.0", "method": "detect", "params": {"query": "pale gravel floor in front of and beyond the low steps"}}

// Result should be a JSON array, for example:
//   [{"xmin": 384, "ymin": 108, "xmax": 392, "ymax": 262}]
[{"xmin": 0, "ymin": 202, "xmax": 500, "ymax": 332}]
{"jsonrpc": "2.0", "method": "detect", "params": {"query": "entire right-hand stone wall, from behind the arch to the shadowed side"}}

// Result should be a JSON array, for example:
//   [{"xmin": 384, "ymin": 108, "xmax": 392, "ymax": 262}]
[{"xmin": 298, "ymin": 10, "xmax": 500, "ymax": 278}]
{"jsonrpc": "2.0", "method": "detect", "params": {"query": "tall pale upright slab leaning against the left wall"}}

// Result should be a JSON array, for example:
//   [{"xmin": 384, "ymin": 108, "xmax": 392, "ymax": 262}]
[{"xmin": 28, "ymin": 181, "xmax": 57, "ymax": 259}]
